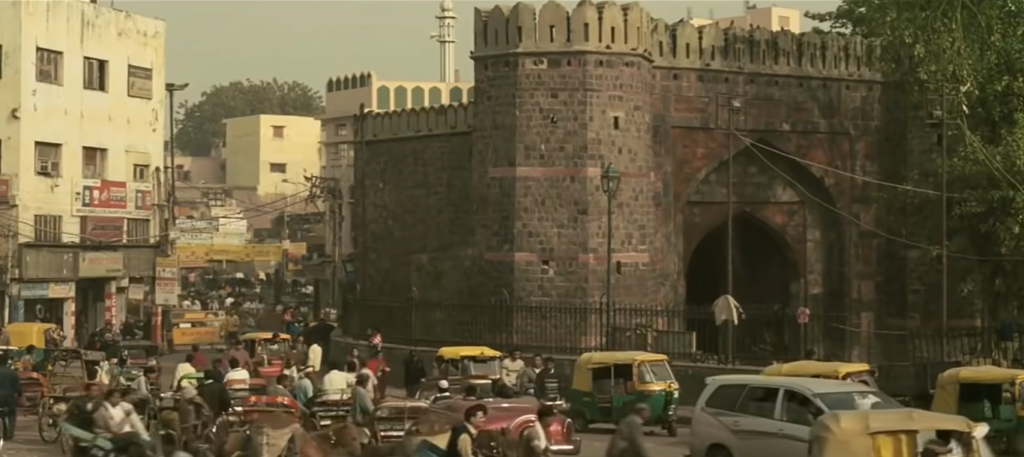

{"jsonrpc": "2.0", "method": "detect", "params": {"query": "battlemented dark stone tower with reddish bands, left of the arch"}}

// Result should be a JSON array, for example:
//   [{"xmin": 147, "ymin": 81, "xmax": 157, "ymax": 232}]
[{"xmin": 472, "ymin": 0, "xmax": 664, "ymax": 303}]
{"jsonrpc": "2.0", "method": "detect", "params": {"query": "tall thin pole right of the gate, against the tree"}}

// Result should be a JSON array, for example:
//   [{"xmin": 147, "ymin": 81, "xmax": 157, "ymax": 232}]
[{"xmin": 926, "ymin": 83, "xmax": 957, "ymax": 358}]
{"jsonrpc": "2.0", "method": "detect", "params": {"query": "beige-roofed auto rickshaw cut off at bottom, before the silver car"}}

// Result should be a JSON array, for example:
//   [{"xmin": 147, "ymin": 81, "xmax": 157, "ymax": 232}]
[{"xmin": 806, "ymin": 408, "xmax": 995, "ymax": 457}]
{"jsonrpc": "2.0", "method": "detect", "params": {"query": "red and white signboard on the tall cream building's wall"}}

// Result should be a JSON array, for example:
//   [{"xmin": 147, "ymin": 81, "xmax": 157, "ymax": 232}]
[{"xmin": 72, "ymin": 179, "xmax": 153, "ymax": 219}]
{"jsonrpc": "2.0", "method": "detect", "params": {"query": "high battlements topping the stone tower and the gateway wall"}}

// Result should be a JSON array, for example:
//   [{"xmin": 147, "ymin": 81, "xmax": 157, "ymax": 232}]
[{"xmin": 473, "ymin": 0, "xmax": 881, "ymax": 79}]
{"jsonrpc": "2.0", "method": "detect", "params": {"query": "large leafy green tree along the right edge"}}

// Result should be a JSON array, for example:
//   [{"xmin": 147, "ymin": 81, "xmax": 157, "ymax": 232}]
[{"xmin": 806, "ymin": 0, "xmax": 1024, "ymax": 311}]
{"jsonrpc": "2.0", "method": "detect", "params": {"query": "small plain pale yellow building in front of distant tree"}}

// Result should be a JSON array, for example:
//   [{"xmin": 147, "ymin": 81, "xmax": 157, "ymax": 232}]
[{"xmin": 222, "ymin": 115, "xmax": 321, "ymax": 196}]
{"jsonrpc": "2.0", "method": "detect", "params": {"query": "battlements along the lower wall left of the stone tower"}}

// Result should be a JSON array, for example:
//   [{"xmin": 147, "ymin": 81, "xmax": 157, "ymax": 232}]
[{"xmin": 367, "ymin": 103, "xmax": 473, "ymax": 140}]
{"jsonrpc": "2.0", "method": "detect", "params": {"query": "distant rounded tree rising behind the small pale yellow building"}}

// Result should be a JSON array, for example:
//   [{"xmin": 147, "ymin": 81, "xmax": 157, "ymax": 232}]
[{"xmin": 174, "ymin": 79, "xmax": 324, "ymax": 156}]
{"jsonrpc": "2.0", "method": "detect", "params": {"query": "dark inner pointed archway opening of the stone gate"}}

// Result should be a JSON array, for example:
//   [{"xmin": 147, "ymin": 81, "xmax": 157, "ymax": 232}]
[{"xmin": 686, "ymin": 212, "xmax": 800, "ymax": 359}]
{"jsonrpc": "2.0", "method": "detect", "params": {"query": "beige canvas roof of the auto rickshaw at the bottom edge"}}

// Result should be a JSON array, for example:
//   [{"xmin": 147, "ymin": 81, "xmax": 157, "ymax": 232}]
[{"xmin": 810, "ymin": 408, "xmax": 976, "ymax": 457}]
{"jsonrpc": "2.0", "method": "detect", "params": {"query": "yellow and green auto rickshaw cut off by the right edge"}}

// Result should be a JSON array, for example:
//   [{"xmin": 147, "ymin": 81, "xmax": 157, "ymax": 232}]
[{"xmin": 932, "ymin": 366, "xmax": 1024, "ymax": 451}]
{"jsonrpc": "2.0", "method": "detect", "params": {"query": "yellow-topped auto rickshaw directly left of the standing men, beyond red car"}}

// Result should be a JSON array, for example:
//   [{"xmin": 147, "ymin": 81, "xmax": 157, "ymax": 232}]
[{"xmin": 431, "ymin": 346, "xmax": 502, "ymax": 398}]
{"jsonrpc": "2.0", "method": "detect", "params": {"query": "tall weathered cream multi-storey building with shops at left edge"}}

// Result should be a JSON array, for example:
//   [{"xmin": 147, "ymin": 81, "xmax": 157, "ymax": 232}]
[{"xmin": 0, "ymin": 0, "xmax": 166, "ymax": 342}]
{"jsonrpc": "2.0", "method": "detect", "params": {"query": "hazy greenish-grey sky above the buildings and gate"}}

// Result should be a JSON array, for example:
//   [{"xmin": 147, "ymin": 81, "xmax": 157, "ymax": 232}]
[{"xmin": 116, "ymin": 0, "xmax": 839, "ymax": 100}]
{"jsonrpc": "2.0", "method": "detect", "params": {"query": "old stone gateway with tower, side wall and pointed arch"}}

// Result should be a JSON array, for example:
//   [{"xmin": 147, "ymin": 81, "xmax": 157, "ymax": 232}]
[{"xmin": 353, "ymin": 0, "xmax": 913, "ymax": 357}]
